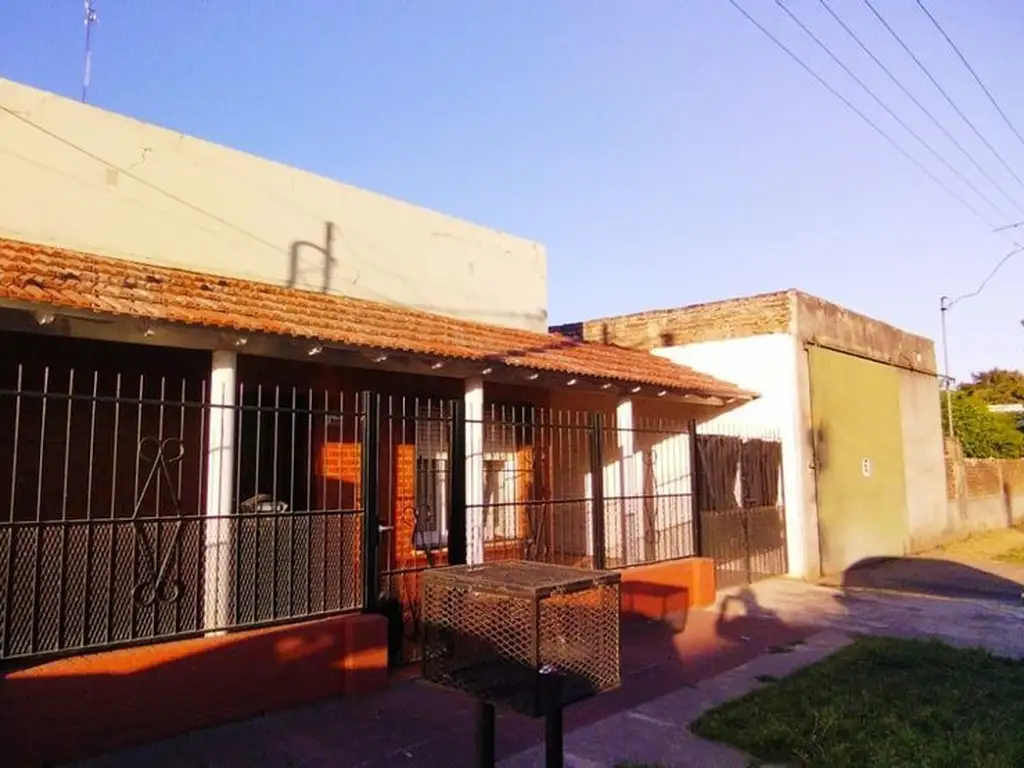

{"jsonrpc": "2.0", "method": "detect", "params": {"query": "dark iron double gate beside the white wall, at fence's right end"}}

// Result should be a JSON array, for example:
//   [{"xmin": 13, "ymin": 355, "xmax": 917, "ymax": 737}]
[{"xmin": 693, "ymin": 430, "xmax": 788, "ymax": 589}]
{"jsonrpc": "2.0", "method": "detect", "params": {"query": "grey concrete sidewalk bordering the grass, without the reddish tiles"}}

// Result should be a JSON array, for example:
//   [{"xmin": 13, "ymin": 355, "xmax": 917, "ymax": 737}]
[{"xmin": 501, "ymin": 579, "xmax": 1024, "ymax": 768}]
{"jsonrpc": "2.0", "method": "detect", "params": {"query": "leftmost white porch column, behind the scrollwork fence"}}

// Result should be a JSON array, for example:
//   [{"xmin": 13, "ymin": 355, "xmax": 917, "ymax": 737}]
[{"xmin": 203, "ymin": 350, "xmax": 238, "ymax": 632}]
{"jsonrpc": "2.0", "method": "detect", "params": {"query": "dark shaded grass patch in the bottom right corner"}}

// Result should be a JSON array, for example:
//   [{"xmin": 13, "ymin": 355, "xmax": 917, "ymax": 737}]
[{"xmin": 692, "ymin": 638, "xmax": 1024, "ymax": 768}]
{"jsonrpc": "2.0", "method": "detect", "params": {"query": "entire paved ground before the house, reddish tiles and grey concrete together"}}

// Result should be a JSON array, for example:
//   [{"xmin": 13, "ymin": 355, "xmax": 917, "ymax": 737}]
[{"xmin": 68, "ymin": 579, "xmax": 1024, "ymax": 768}]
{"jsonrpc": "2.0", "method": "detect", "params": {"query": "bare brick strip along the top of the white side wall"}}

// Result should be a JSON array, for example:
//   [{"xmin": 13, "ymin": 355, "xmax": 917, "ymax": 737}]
[{"xmin": 552, "ymin": 291, "xmax": 794, "ymax": 349}]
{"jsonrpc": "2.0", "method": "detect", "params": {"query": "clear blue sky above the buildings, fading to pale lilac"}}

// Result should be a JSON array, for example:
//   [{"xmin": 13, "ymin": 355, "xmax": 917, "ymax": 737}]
[{"xmin": 0, "ymin": 0, "xmax": 1024, "ymax": 377}]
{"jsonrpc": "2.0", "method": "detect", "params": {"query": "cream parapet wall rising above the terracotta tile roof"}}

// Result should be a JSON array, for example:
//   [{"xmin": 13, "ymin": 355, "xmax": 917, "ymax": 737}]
[{"xmin": 0, "ymin": 79, "xmax": 548, "ymax": 332}]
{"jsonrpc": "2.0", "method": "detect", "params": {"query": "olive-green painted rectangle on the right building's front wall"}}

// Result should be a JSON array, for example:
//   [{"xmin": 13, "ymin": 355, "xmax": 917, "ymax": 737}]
[{"xmin": 808, "ymin": 347, "xmax": 907, "ymax": 574}]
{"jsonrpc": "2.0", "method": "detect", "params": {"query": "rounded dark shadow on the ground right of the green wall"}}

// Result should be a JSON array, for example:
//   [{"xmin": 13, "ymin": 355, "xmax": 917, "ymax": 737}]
[{"xmin": 826, "ymin": 557, "xmax": 1024, "ymax": 605}]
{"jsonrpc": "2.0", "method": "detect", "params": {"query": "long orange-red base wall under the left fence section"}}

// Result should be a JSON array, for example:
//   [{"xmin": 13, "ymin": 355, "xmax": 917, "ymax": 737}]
[{"xmin": 0, "ymin": 615, "xmax": 387, "ymax": 766}]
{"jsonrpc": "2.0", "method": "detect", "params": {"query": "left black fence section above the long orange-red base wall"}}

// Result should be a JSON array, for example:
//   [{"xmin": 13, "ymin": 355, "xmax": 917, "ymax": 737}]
[{"xmin": 0, "ymin": 365, "xmax": 362, "ymax": 659}]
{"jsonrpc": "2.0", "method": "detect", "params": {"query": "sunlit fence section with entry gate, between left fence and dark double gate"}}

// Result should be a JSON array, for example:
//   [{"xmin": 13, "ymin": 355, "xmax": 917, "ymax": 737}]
[{"xmin": 373, "ymin": 396, "xmax": 695, "ymax": 662}]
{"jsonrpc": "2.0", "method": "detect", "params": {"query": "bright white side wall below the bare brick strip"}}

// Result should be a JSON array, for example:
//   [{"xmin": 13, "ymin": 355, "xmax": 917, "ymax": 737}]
[{"xmin": 653, "ymin": 334, "xmax": 816, "ymax": 577}]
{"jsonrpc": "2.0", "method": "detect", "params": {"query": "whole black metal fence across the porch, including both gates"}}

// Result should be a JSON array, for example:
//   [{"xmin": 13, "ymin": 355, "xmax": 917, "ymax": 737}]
[{"xmin": 0, "ymin": 361, "xmax": 784, "ymax": 659}]
